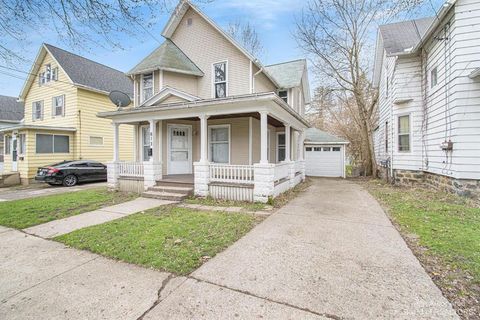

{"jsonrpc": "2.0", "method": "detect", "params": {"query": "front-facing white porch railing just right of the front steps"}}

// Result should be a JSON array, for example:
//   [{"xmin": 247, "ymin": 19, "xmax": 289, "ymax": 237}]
[{"xmin": 210, "ymin": 163, "xmax": 254, "ymax": 184}]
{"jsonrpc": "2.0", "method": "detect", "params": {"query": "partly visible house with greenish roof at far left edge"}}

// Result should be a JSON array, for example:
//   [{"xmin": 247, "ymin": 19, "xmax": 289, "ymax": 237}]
[{"xmin": 0, "ymin": 95, "xmax": 25, "ymax": 173}]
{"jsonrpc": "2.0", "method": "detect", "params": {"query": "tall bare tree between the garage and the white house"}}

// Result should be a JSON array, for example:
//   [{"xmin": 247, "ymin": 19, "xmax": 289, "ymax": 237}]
[{"xmin": 296, "ymin": 0, "xmax": 421, "ymax": 175}]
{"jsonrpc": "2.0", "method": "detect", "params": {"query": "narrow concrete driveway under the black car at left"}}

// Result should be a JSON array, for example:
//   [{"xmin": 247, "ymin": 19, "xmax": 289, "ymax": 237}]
[{"xmin": 0, "ymin": 182, "xmax": 107, "ymax": 202}]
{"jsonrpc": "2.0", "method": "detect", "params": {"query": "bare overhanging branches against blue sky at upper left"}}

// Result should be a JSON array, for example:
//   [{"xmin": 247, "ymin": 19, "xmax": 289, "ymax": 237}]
[{"xmin": 0, "ymin": 0, "xmax": 213, "ymax": 63}]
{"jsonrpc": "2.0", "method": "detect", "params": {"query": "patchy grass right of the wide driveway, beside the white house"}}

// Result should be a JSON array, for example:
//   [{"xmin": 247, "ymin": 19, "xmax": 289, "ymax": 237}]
[{"xmin": 367, "ymin": 181, "xmax": 480, "ymax": 283}]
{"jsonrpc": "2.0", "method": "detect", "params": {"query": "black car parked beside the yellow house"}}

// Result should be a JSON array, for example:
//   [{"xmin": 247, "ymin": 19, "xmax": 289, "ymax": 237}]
[{"xmin": 35, "ymin": 160, "xmax": 107, "ymax": 187}]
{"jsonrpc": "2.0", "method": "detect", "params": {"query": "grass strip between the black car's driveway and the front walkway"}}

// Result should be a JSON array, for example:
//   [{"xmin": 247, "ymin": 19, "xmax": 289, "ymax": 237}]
[{"xmin": 0, "ymin": 188, "xmax": 137, "ymax": 229}]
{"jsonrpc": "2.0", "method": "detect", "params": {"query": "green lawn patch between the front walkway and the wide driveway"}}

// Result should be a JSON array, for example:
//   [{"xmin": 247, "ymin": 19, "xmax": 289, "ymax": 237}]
[{"xmin": 55, "ymin": 206, "xmax": 256, "ymax": 275}]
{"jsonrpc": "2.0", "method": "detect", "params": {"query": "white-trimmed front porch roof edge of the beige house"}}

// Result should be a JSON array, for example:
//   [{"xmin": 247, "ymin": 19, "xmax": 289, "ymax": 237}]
[{"xmin": 97, "ymin": 92, "xmax": 309, "ymax": 127}]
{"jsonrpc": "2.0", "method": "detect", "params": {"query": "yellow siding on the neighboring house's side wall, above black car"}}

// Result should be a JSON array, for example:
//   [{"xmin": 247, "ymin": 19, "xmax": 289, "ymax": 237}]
[{"xmin": 77, "ymin": 89, "xmax": 134, "ymax": 162}]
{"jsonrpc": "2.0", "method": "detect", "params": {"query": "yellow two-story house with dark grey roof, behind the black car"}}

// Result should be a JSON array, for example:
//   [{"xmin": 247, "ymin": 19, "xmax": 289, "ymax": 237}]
[{"xmin": 0, "ymin": 44, "xmax": 134, "ymax": 184}]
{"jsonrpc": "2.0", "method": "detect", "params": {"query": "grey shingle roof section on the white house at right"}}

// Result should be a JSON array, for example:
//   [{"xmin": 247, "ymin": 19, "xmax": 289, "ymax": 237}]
[{"xmin": 380, "ymin": 17, "xmax": 435, "ymax": 54}]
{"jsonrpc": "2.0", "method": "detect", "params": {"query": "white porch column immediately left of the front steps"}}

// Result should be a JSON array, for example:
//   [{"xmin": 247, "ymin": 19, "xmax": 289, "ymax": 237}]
[{"xmin": 143, "ymin": 120, "xmax": 162, "ymax": 190}]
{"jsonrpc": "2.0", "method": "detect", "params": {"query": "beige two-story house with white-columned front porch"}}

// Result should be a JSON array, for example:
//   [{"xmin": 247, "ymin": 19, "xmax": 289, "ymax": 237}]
[{"xmin": 99, "ymin": 1, "xmax": 310, "ymax": 202}]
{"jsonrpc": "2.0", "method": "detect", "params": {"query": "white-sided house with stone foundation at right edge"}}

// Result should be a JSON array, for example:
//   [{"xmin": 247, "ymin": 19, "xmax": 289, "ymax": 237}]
[{"xmin": 373, "ymin": 0, "xmax": 480, "ymax": 198}]
